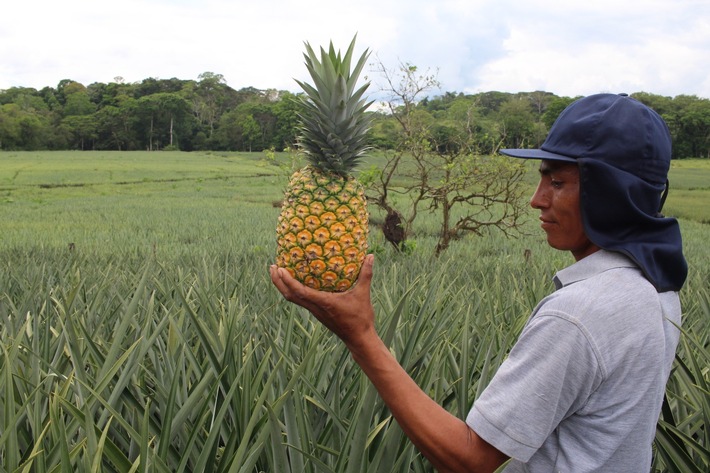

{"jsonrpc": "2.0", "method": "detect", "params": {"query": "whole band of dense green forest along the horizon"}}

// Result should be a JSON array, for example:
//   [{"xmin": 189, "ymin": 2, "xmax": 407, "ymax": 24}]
[{"xmin": 0, "ymin": 72, "xmax": 710, "ymax": 158}]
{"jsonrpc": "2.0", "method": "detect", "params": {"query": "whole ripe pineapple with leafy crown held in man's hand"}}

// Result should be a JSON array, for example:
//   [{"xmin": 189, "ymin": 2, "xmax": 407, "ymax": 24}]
[{"xmin": 276, "ymin": 38, "xmax": 372, "ymax": 292}]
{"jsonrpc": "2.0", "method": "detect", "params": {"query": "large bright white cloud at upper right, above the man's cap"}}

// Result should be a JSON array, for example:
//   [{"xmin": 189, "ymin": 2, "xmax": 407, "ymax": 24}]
[{"xmin": 469, "ymin": 1, "xmax": 710, "ymax": 97}]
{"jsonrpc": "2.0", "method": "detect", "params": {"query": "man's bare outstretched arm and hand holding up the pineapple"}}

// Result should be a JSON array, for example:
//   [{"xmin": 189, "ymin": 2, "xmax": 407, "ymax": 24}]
[{"xmin": 270, "ymin": 255, "xmax": 507, "ymax": 472}]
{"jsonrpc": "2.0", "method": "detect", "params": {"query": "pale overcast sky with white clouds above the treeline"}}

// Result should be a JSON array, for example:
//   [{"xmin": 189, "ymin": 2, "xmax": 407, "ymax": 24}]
[{"xmin": 0, "ymin": 0, "xmax": 710, "ymax": 98}]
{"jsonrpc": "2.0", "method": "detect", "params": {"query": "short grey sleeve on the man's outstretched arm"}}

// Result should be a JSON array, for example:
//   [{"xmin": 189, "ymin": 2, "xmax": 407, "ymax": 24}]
[{"xmin": 466, "ymin": 311, "xmax": 602, "ymax": 462}]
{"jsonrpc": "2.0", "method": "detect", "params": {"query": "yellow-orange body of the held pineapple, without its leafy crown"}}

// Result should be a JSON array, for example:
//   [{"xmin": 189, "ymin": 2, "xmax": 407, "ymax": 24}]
[{"xmin": 276, "ymin": 166, "xmax": 368, "ymax": 292}]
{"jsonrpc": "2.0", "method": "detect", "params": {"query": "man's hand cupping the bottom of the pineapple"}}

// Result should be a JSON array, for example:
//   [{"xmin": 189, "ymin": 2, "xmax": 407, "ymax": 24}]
[{"xmin": 269, "ymin": 255, "xmax": 375, "ymax": 349}]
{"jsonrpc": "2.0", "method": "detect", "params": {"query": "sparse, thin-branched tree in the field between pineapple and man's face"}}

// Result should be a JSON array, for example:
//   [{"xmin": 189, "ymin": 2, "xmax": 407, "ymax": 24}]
[{"xmin": 368, "ymin": 61, "xmax": 526, "ymax": 255}]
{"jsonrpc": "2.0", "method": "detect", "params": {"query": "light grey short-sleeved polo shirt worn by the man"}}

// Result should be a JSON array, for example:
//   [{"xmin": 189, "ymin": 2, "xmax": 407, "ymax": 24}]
[{"xmin": 466, "ymin": 250, "xmax": 680, "ymax": 473}]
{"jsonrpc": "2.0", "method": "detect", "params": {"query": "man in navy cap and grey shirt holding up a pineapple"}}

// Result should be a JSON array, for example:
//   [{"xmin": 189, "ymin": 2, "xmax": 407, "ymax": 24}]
[{"xmin": 271, "ymin": 94, "xmax": 687, "ymax": 473}]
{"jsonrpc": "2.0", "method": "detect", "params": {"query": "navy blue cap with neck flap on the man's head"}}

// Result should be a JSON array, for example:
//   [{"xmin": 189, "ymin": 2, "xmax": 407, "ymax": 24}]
[{"xmin": 501, "ymin": 94, "xmax": 688, "ymax": 292}]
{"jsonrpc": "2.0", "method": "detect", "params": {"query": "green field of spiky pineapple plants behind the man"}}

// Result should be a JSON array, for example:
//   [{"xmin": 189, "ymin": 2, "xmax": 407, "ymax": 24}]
[{"xmin": 0, "ymin": 152, "xmax": 710, "ymax": 473}]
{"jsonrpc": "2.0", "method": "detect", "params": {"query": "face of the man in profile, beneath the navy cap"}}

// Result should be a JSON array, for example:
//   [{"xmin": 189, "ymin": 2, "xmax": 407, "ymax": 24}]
[{"xmin": 530, "ymin": 160, "xmax": 599, "ymax": 261}]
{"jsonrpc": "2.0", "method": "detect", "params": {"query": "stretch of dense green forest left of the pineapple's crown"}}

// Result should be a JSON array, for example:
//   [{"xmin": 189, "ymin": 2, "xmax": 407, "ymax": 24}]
[{"xmin": 0, "ymin": 77, "xmax": 295, "ymax": 151}]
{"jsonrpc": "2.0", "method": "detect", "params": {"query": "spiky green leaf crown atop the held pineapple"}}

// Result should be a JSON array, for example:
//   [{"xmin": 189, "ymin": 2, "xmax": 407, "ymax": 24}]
[{"xmin": 296, "ymin": 35, "xmax": 372, "ymax": 176}]
